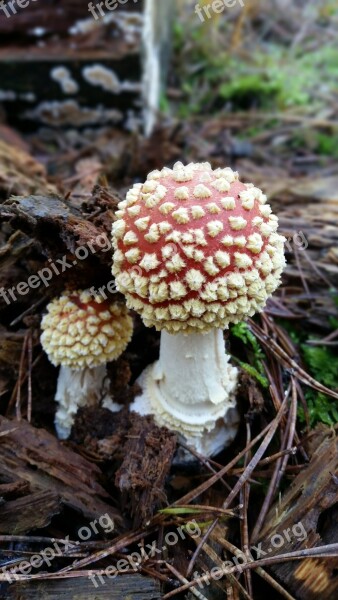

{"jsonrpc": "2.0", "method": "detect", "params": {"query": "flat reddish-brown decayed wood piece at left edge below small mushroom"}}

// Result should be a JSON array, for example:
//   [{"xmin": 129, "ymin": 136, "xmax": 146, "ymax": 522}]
[{"xmin": 0, "ymin": 417, "xmax": 122, "ymax": 532}]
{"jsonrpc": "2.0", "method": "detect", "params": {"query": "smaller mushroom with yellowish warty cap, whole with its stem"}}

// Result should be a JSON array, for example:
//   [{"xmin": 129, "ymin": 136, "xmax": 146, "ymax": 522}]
[{"xmin": 41, "ymin": 290, "xmax": 133, "ymax": 439}]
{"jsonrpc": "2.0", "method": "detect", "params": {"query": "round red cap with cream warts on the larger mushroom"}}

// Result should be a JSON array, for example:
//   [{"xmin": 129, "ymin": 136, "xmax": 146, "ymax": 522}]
[{"xmin": 113, "ymin": 163, "xmax": 285, "ymax": 333}]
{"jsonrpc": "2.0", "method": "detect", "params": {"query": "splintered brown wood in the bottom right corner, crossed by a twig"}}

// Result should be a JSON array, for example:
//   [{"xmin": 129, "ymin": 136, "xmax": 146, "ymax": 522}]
[{"xmin": 259, "ymin": 426, "xmax": 338, "ymax": 600}]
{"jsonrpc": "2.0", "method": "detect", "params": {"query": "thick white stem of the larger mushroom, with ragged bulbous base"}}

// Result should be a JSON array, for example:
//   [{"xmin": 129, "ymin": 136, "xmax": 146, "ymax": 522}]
[{"xmin": 131, "ymin": 329, "xmax": 238, "ymax": 455}]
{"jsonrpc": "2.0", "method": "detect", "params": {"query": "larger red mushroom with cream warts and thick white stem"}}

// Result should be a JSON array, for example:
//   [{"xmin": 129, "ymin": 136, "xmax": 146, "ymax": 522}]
[{"xmin": 113, "ymin": 162, "xmax": 285, "ymax": 455}]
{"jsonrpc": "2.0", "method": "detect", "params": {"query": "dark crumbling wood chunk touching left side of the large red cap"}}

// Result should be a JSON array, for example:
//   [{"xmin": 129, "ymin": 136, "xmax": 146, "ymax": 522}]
[{"xmin": 0, "ymin": 186, "xmax": 119, "ymax": 302}]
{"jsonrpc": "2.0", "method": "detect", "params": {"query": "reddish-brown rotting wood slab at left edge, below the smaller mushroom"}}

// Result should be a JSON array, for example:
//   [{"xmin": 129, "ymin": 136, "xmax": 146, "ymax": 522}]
[{"xmin": 0, "ymin": 417, "xmax": 122, "ymax": 532}]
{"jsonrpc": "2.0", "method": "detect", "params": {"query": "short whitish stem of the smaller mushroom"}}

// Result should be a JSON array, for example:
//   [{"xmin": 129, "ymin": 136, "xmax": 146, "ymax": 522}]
[{"xmin": 55, "ymin": 365, "xmax": 109, "ymax": 440}]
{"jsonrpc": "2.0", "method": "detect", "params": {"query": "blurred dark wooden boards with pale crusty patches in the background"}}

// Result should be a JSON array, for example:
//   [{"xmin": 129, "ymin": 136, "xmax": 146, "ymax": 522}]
[{"xmin": 0, "ymin": 0, "xmax": 143, "ymax": 130}]
